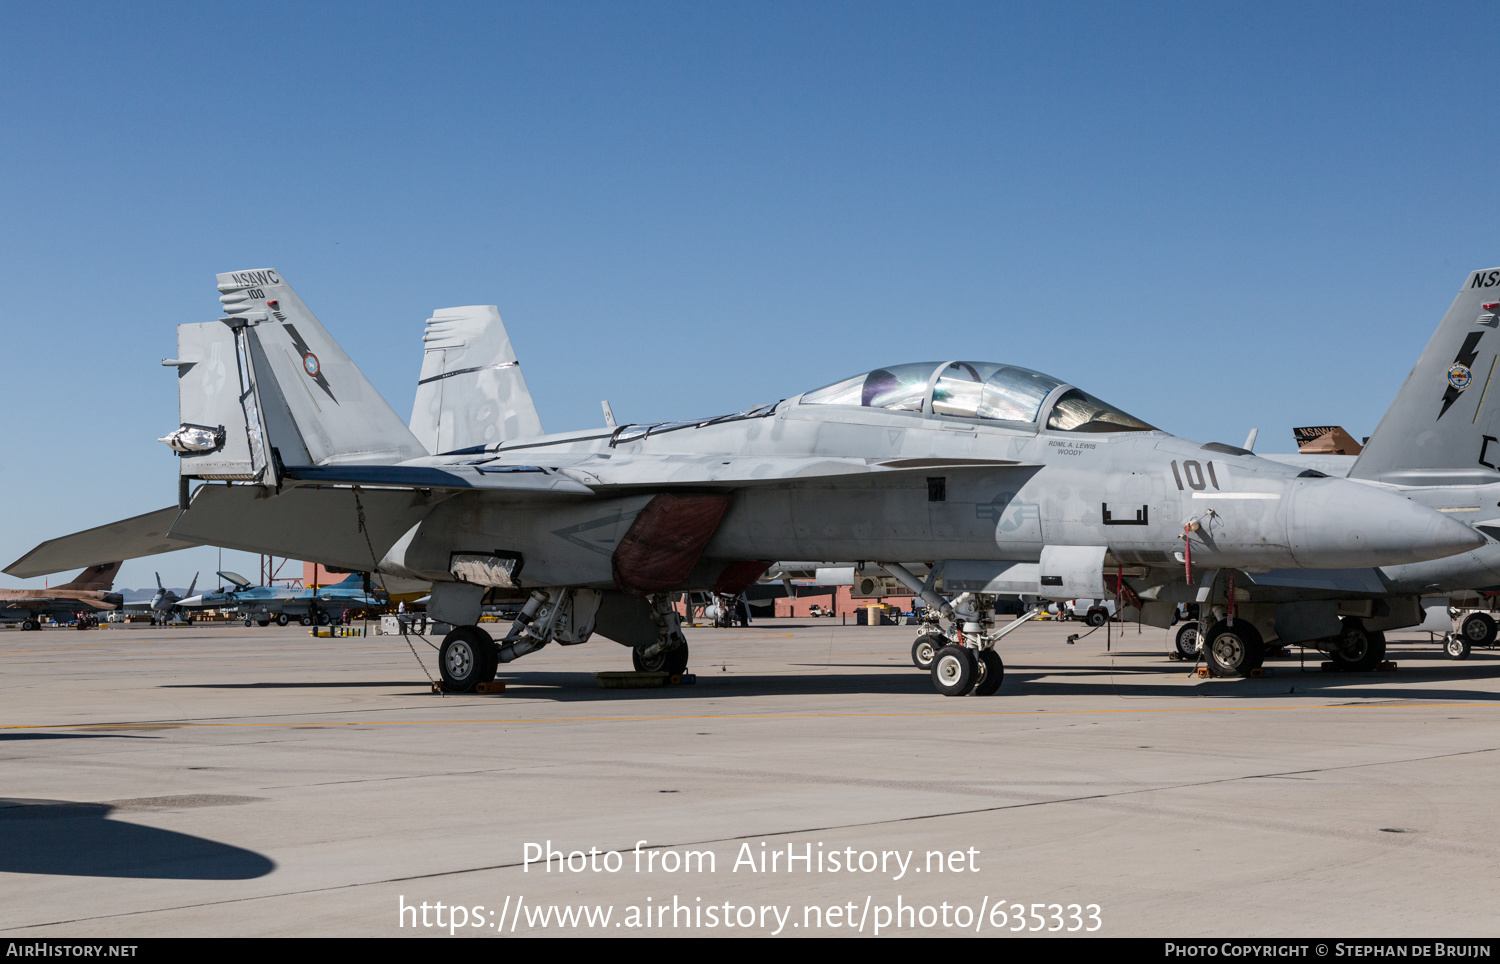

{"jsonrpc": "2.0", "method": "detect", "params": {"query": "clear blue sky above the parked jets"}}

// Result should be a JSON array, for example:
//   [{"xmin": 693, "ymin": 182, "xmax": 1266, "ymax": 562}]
[{"xmin": 0, "ymin": 1, "xmax": 1500, "ymax": 586}]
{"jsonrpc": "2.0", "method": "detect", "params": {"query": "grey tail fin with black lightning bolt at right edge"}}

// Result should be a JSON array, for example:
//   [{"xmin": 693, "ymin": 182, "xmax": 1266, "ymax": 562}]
[{"xmin": 1349, "ymin": 268, "xmax": 1500, "ymax": 486}]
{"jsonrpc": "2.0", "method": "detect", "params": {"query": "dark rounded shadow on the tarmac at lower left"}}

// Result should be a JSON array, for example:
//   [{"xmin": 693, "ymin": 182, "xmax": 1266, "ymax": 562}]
[{"xmin": 0, "ymin": 799, "xmax": 276, "ymax": 880}]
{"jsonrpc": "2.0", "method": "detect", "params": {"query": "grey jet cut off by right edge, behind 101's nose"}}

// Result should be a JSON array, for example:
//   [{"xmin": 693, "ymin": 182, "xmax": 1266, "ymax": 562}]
[{"xmin": 1164, "ymin": 268, "xmax": 1500, "ymax": 670}]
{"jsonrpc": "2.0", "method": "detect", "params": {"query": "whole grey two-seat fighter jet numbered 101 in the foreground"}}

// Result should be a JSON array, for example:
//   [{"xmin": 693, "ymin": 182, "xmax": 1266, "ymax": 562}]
[{"xmin": 6, "ymin": 270, "xmax": 1484, "ymax": 694}]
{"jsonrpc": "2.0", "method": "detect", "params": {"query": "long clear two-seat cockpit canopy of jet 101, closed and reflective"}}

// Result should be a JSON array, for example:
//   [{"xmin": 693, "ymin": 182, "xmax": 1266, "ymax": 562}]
[{"xmin": 801, "ymin": 361, "xmax": 1155, "ymax": 432}]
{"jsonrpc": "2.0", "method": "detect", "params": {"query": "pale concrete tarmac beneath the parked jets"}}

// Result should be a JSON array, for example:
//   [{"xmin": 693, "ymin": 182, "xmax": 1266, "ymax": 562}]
[{"xmin": 0, "ymin": 619, "xmax": 1500, "ymax": 939}]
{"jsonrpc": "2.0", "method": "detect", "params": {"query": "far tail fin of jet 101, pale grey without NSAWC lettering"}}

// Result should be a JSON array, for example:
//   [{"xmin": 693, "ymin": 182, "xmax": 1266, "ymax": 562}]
[{"xmin": 411, "ymin": 304, "xmax": 542, "ymax": 454}]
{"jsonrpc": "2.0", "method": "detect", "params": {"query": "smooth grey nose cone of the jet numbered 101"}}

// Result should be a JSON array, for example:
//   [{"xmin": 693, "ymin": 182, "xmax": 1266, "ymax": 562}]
[{"xmin": 1287, "ymin": 478, "xmax": 1485, "ymax": 568}]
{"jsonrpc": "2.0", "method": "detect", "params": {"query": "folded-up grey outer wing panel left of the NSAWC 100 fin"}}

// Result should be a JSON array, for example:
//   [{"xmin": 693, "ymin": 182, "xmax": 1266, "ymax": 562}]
[{"xmin": 173, "ymin": 321, "xmax": 266, "ymax": 481}]
